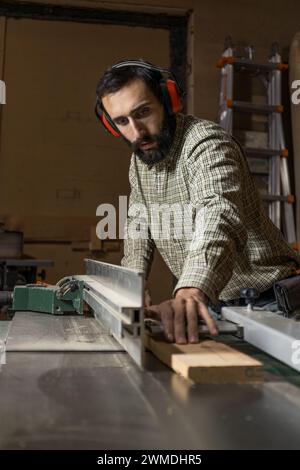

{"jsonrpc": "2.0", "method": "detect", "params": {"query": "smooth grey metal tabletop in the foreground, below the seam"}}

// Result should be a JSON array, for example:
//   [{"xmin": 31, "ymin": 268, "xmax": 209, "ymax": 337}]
[{"xmin": 0, "ymin": 312, "xmax": 300, "ymax": 450}]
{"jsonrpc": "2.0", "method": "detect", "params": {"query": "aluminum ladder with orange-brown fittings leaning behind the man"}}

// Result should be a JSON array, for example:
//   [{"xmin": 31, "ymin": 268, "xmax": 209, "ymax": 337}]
[{"xmin": 217, "ymin": 37, "xmax": 298, "ymax": 249}]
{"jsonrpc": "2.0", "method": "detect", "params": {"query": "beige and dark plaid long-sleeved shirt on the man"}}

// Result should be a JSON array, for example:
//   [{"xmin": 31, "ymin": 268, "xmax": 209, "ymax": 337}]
[{"xmin": 122, "ymin": 114, "xmax": 300, "ymax": 303}]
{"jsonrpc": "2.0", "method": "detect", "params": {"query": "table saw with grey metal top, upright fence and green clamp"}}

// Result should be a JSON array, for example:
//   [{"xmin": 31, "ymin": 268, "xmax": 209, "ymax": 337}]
[{"xmin": 0, "ymin": 260, "xmax": 300, "ymax": 450}]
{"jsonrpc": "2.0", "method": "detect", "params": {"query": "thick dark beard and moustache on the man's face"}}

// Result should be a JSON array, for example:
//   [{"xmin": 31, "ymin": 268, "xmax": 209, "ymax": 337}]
[{"xmin": 127, "ymin": 115, "xmax": 176, "ymax": 165}]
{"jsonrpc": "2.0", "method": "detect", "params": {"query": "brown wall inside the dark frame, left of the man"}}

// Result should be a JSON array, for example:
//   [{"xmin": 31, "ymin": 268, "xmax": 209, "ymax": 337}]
[{"xmin": 0, "ymin": 15, "xmax": 172, "ymax": 297}]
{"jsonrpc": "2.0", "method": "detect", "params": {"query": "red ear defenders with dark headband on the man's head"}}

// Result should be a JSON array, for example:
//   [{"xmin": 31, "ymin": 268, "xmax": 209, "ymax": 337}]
[{"xmin": 95, "ymin": 60, "xmax": 183, "ymax": 137}]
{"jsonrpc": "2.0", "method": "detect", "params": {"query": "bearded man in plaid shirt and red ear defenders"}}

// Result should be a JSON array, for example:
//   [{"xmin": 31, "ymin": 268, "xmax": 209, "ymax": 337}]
[{"xmin": 97, "ymin": 60, "xmax": 299, "ymax": 344}]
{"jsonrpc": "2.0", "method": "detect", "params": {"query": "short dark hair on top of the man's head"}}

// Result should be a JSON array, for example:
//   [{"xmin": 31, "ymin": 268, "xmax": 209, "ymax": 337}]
[{"xmin": 96, "ymin": 59, "xmax": 164, "ymax": 103}]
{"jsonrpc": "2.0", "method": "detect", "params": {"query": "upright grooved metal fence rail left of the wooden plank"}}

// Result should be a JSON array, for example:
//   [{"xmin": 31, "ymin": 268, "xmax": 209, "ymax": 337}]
[{"xmin": 75, "ymin": 259, "xmax": 144, "ymax": 367}]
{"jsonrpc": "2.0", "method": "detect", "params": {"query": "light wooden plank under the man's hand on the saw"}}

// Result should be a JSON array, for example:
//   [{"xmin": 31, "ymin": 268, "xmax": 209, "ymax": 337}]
[{"xmin": 146, "ymin": 334, "xmax": 263, "ymax": 384}]
